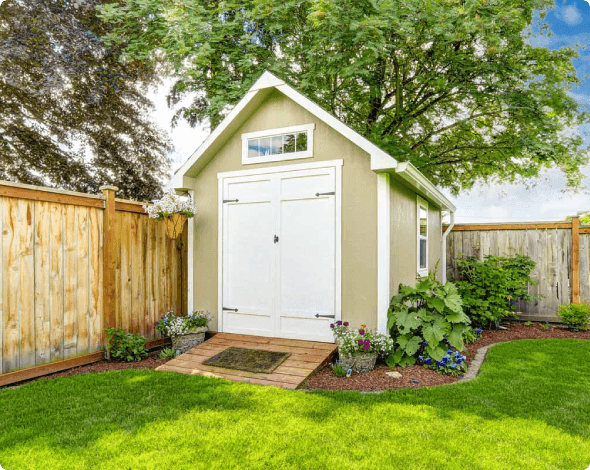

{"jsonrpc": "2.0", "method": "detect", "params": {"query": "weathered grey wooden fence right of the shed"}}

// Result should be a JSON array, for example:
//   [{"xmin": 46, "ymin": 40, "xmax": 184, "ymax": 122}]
[{"xmin": 447, "ymin": 218, "xmax": 590, "ymax": 321}]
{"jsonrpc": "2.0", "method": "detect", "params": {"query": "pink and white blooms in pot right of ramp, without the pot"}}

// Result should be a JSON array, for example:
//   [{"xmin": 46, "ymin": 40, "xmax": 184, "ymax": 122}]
[{"xmin": 330, "ymin": 321, "xmax": 393, "ymax": 356}]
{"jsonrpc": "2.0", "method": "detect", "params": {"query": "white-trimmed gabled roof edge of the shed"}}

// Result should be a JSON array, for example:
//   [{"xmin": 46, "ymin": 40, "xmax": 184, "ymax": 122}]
[{"xmin": 167, "ymin": 72, "xmax": 455, "ymax": 211}]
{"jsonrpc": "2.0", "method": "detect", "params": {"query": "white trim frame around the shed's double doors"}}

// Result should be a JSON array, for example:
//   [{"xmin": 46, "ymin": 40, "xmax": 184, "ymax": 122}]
[{"xmin": 217, "ymin": 159, "xmax": 344, "ymax": 332}]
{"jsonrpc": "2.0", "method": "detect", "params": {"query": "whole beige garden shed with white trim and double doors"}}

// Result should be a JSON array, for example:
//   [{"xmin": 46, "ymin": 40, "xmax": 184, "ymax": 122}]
[{"xmin": 168, "ymin": 72, "xmax": 455, "ymax": 341}]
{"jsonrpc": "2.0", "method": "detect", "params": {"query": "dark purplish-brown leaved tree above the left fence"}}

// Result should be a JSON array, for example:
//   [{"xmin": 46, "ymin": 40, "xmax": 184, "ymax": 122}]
[{"xmin": 0, "ymin": 0, "xmax": 170, "ymax": 200}]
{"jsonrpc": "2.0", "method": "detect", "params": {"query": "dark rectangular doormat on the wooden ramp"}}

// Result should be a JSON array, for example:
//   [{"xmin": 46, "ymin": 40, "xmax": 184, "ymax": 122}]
[{"xmin": 203, "ymin": 347, "xmax": 291, "ymax": 374}]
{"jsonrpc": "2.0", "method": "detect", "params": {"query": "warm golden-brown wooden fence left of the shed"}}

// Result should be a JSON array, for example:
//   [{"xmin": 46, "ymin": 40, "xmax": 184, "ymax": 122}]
[{"xmin": 0, "ymin": 182, "xmax": 187, "ymax": 386}]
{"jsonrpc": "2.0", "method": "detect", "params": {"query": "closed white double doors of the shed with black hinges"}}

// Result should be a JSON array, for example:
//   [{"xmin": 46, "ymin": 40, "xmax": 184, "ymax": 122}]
[{"xmin": 221, "ymin": 167, "xmax": 336, "ymax": 342}]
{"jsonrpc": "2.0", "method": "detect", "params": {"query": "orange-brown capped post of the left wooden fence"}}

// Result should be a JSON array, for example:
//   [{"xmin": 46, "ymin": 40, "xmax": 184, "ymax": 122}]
[{"xmin": 100, "ymin": 186, "xmax": 119, "ymax": 336}]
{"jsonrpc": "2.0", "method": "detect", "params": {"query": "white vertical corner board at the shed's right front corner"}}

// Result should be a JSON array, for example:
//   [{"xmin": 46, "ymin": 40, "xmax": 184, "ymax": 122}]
[{"xmin": 377, "ymin": 173, "xmax": 391, "ymax": 334}]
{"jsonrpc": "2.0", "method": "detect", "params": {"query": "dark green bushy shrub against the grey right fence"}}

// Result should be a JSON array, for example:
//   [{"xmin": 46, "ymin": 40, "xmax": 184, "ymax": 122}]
[{"xmin": 453, "ymin": 254, "xmax": 539, "ymax": 326}]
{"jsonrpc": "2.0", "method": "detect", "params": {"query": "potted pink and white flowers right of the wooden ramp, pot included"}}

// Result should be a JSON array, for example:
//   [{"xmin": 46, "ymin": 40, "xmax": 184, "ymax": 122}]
[{"xmin": 330, "ymin": 322, "xmax": 394, "ymax": 374}]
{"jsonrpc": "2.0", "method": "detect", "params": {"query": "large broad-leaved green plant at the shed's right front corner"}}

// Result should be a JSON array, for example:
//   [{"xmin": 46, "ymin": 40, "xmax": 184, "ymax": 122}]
[{"xmin": 387, "ymin": 276, "xmax": 470, "ymax": 367}]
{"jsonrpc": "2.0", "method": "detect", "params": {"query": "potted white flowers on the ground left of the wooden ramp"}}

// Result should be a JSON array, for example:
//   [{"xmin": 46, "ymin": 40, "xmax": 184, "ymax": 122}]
[{"xmin": 156, "ymin": 312, "xmax": 211, "ymax": 354}]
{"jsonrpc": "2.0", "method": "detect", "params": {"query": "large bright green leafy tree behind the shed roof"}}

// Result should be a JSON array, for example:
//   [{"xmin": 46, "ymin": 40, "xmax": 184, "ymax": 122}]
[{"xmin": 101, "ymin": 0, "xmax": 589, "ymax": 192}]
